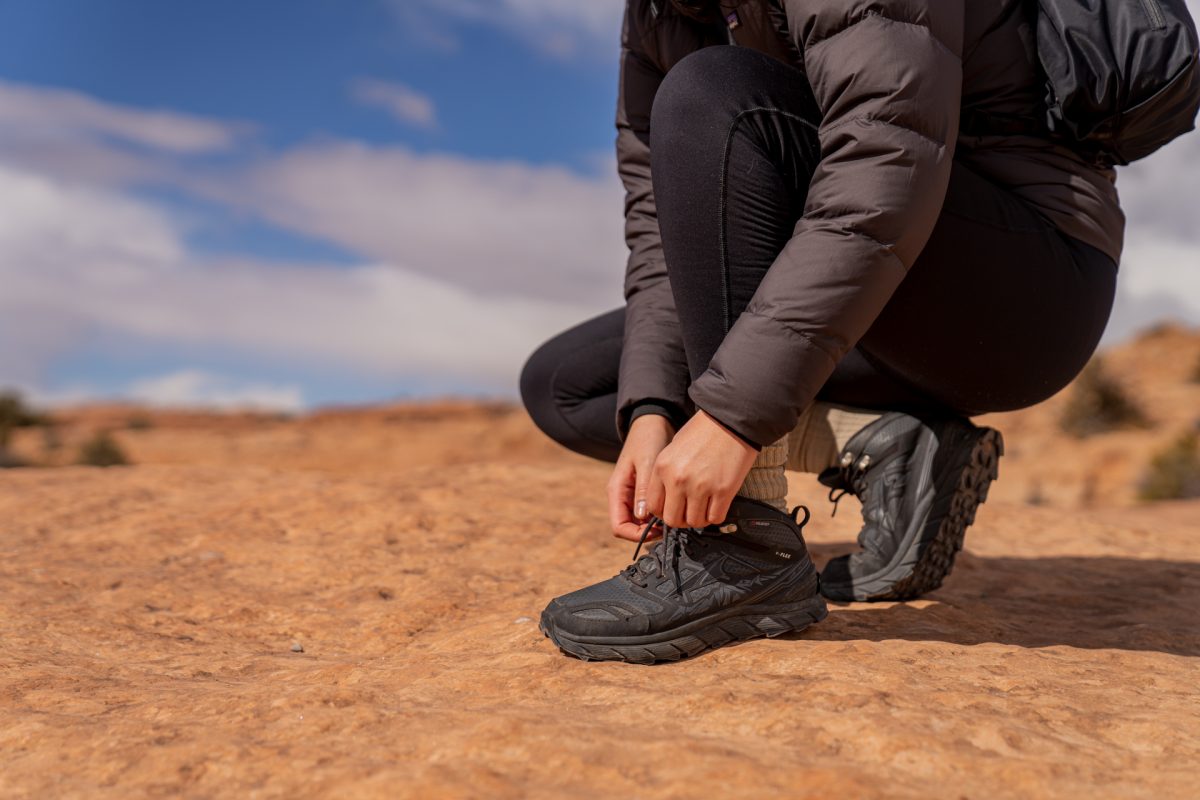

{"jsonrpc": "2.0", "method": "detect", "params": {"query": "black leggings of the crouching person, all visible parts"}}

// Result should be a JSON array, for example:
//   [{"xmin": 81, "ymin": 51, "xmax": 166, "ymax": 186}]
[{"xmin": 521, "ymin": 47, "xmax": 1117, "ymax": 461}]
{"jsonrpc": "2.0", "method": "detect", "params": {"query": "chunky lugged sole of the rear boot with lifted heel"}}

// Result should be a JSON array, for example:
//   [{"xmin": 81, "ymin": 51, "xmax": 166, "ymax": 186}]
[{"xmin": 821, "ymin": 428, "xmax": 1004, "ymax": 602}]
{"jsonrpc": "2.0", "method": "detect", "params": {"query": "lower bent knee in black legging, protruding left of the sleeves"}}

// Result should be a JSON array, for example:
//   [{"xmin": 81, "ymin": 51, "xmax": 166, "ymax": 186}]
[{"xmin": 521, "ymin": 307, "xmax": 625, "ymax": 462}]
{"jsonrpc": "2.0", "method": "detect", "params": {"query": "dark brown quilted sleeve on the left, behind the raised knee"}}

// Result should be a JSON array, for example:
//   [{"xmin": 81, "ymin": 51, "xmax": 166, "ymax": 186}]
[{"xmin": 617, "ymin": 1, "xmax": 692, "ymax": 440}]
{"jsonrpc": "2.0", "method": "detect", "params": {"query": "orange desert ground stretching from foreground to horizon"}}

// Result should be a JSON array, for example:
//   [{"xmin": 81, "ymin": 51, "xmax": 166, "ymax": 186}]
[{"xmin": 0, "ymin": 329, "xmax": 1200, "ymax": 798}]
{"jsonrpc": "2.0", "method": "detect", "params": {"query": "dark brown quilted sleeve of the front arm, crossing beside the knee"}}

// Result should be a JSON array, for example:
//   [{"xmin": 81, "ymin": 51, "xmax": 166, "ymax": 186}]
[{"xmin": 689, "ymin": 0, "xmax": 965, "ymax": 444}]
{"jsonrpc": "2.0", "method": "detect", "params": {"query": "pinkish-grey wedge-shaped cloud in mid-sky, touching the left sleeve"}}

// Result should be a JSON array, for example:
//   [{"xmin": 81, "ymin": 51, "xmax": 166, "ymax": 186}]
[{"xmin": 200, "ymin": 143, "xmax": 626, "ymax": 307}]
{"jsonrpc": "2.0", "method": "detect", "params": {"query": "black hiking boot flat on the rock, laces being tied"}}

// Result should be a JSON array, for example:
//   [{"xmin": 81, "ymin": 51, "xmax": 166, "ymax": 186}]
[{"xmin": 540, "ymin": 497, "xmax": 826, "ymax": 663}]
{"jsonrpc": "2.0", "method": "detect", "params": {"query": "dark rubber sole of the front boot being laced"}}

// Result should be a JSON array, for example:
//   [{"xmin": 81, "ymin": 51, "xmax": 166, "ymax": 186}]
[{"xmin": 538, "ymin": 595, "xmax": 829, "ymax": 664}]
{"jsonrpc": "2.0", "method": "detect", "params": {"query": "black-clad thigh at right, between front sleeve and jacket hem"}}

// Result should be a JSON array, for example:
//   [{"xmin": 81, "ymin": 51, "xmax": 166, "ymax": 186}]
[{"xmin": 859, "ymin": 162, "xmax": 1116, "ymax": 414}]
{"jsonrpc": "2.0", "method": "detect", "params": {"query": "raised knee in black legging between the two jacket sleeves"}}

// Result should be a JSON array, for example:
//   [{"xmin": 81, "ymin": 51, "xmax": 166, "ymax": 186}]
[{"xmin": 650, "ymin": 46, "xmax": 821, "ymax": 379}]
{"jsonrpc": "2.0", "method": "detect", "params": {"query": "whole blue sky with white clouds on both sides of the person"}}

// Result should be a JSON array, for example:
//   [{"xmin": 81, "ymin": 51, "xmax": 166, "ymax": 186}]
[{"xmin": 0, "ymin": 0, "xmax": 1200, "ymax": 409}]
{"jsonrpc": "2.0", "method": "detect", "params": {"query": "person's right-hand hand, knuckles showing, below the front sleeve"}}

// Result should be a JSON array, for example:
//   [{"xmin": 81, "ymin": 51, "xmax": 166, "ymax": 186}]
[{"xmin": 647, "ymin": 410, "xmax": 758, "ymax": 528}]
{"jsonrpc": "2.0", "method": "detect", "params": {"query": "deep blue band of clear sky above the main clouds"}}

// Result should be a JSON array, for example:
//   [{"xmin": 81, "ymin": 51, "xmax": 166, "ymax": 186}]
[{"xmin": 0, "ymin": 0, "xmax": 618, "ymax": 160}]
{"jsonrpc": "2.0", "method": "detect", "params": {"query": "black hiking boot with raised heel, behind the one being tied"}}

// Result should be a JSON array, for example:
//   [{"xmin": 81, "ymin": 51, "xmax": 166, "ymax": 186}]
[{"xmin": 817, "ymin": 413, "xmax": 1004, "ymax": 601}]
